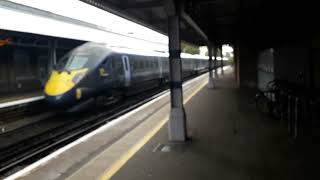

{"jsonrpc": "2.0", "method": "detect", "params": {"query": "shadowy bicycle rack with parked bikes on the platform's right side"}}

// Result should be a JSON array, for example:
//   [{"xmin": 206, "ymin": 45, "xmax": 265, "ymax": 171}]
[{"xmin": 254, "ymin": 80, "xmax": 320, "ymax": 141}]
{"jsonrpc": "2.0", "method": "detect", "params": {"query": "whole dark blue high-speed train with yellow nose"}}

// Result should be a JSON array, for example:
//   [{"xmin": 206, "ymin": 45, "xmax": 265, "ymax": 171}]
[{"xmin": 44, "ymin": 42, "xmax": 215, "ymax": 111}]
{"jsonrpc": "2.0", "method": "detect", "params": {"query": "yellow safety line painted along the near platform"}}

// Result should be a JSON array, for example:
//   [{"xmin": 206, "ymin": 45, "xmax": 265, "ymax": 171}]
[{"xmin": 100, "ymin": 79, "xmax": 207, "ymax": 180}]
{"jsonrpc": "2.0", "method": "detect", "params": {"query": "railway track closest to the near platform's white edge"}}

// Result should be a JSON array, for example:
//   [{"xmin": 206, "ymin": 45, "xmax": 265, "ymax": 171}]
[{"xmin": 0, "ymin": 86, "xmax": 168, "ymax": 178}]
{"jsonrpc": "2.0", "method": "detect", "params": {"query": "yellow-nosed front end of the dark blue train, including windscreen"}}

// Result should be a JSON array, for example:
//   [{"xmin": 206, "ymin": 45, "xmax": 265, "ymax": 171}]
[{"xmin": 44, "ymin": 43, "xmax": 107, "ymax": 109}]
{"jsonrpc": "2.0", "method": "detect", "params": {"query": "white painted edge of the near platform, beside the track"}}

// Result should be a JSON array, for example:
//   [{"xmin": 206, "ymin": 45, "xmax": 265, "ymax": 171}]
[{"xmin": 4, "ymin": 73, "xmax": 212, "ymax": 180}]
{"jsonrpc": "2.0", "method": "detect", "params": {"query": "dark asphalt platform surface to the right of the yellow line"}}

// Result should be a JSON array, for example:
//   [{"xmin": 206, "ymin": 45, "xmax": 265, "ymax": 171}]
[{"xmin": 111, "ymin": 69, "xmax": 320, "ymax": 180}]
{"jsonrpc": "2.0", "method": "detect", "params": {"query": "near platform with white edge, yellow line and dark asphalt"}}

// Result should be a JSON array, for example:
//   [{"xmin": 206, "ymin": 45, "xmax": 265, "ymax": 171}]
[{"xmin": 7, "ymin": 66, "xmax": 320, "ymax": 180}]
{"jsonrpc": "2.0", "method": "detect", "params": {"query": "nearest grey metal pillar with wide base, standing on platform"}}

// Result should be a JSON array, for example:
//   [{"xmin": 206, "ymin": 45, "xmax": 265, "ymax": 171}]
[{"xmin": 168, "ymin": 13, "xmax": 187, "ymax": 142}]
